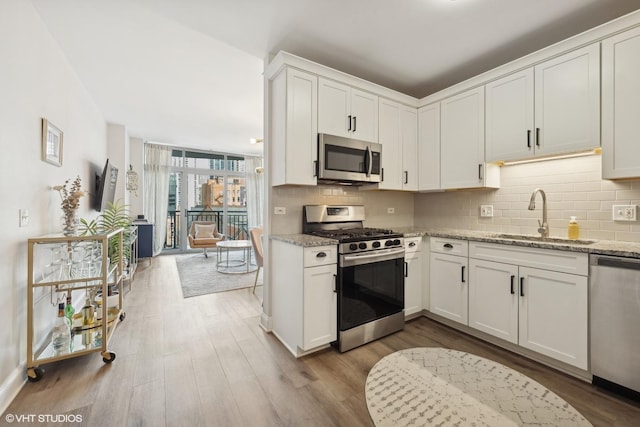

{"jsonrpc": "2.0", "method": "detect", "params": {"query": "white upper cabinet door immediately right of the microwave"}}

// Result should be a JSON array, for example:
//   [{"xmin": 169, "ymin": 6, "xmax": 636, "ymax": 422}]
[{"xmin": 378, "ymin": 98, "xmax": 402, "ymax": 190}]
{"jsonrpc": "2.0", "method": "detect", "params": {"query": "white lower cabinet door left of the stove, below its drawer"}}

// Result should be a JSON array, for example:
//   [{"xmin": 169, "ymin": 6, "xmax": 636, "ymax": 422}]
[{"xmin": 302, "ymin": 264, "xmax": 338, "ymax": 350}]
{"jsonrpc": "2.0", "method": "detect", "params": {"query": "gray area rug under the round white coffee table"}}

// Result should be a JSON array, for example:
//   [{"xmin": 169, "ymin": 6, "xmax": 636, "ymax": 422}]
[{"xmin": 175, "ymin": 250, "xmax": 262, "ymax": 298}]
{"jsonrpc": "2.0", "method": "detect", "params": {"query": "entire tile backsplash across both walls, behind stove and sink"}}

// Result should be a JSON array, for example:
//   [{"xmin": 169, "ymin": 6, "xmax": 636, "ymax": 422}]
[{"xmin": 271, "ymin": 156, "xmax": 640, "ymax": 241}]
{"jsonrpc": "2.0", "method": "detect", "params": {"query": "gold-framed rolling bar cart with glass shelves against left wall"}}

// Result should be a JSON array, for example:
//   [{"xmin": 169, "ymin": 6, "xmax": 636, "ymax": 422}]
[{"xmin": 27, "ymin": 229, "xmax": 125, "ymax": 381}]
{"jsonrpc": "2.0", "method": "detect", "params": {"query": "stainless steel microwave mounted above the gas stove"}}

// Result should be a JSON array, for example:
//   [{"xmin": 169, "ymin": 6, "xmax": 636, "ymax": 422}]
[{"xmin": 318, "ymin": 133, "xmax": 382, "ymax": 185}]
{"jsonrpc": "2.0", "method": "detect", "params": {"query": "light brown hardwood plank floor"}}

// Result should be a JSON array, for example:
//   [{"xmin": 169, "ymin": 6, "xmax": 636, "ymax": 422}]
[{"xmin": 5, "ymin": 256, "xmax": 640, "ymax": 427}]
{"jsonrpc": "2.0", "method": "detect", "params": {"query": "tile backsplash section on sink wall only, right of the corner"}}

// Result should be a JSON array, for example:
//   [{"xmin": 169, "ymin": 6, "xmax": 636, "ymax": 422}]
[{"xmin": 414, "ymin": 156, "xmax": 640, "ymax": 241}]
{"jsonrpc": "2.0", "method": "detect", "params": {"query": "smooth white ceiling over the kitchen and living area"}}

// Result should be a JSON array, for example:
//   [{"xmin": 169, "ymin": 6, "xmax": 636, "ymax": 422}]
[{"xmin": 31, "ymin": 0, "xmax": 640, "ymax": 154}]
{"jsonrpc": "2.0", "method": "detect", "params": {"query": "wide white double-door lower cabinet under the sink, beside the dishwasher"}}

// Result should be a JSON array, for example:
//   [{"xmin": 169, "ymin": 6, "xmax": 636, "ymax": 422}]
[{"xmin": 469, "ymin": 242, "xmax": 588, "ymax": 370}]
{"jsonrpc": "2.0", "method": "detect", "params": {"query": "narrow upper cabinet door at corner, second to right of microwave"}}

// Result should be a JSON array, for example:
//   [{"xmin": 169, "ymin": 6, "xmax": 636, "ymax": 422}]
[{"xmin": 400, "ymin": 106, "xmax": 418, "ymax": 191}]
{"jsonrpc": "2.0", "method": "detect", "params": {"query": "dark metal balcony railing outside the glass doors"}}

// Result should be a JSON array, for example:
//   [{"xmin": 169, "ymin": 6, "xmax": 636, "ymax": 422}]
[{"xmin": 164, "ymin": 210, "xmax": 249, "ymax": 249}]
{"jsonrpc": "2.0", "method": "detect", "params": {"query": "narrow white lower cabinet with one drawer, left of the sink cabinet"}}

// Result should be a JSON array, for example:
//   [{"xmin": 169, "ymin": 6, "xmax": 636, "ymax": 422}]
[{"xmin": 429, "ymin": 238, "xmax": 469, "ymax": 325}]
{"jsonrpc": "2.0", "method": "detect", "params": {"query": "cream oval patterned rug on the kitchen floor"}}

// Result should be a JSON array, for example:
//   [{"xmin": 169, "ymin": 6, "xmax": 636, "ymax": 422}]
[{"xmin": 365, "ymin": 347, "xmax": 591, "ymax": 427}]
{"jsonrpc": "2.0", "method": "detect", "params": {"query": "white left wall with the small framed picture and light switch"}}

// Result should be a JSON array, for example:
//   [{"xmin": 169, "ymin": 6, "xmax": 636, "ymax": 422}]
[{"xmin": 0, "ymin": 0, "xmax": 107, "ymax": 413}]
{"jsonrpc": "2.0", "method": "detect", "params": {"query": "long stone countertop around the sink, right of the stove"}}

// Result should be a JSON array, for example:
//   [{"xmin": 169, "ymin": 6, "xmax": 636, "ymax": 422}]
[{"xmin": 394, "ymin": 227, "xmax": 640, "ymax": 258}]
